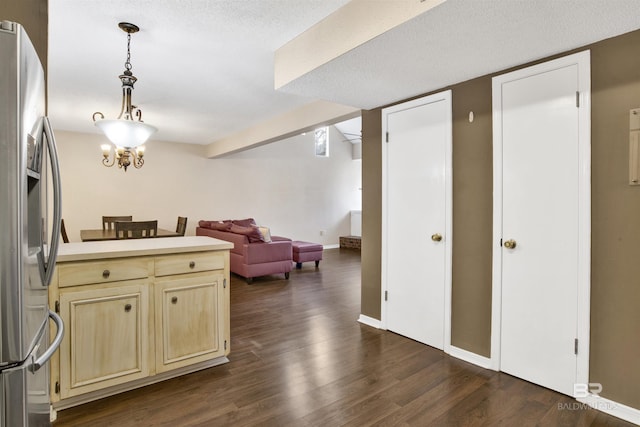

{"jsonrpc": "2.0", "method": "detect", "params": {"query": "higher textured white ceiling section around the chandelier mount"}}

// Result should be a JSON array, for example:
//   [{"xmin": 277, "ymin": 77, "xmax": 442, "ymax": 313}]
[{"xmin": 49, "ymin": 0, "xmax": 348, "ymax": 144}]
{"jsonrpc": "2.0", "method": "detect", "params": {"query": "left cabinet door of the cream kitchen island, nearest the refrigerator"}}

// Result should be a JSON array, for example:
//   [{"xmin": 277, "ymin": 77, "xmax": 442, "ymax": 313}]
[{"xmin": 60, "ymin": 281, "xmax": 150, "ymax": 399}]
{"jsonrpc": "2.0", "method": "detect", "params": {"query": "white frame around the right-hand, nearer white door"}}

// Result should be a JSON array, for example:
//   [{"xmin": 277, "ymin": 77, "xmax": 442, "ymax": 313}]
[{"xmin": 491, "ymin": 50, "xmax": 591, "ymax": 392}]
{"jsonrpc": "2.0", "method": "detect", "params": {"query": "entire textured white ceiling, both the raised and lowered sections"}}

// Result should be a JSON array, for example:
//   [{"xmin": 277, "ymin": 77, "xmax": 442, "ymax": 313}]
[{"xmin": 49, "ymin": 0, "xmax": 640, "ymax": 144}]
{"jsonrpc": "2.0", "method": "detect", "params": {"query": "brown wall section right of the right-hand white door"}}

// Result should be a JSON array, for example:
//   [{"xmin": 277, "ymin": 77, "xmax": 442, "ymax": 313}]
[{"xmin": 589, "ymin": 31, "xmax": 640, "ymax": 409}]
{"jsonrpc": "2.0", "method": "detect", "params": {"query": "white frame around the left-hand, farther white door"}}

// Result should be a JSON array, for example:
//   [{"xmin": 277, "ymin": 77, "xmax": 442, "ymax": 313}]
[{"xmin": 380, "ymin": 90, "xmax": 453, "ymax": 353}]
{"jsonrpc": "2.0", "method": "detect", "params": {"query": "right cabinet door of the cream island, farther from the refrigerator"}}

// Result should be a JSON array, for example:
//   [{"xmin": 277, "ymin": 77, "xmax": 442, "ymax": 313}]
[{"xmin": 155, "ymin": 273, "xmax": 225, "ymax": 372}]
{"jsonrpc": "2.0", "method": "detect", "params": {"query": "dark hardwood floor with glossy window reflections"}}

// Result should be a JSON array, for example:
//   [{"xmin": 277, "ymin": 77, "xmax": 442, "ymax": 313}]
[{"xmin": 54, "ymin": 249, "xmax": 632, "ymax": 427}]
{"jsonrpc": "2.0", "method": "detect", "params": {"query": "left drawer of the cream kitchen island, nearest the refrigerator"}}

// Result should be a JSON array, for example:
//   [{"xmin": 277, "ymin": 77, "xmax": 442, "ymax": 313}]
[{"xmin": 58, "ymin": 258, "xmax": 149, "ymax": 288}]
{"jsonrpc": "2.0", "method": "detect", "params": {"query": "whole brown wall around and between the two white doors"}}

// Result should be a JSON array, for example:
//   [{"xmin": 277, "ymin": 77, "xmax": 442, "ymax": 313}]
[{"xmin": 362, "ymin": 31, "xmax": 640, "ymax": 409}]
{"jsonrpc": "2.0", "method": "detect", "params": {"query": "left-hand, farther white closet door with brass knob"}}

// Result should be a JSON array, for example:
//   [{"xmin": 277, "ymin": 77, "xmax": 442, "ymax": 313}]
[{"xmin": 383, "ymin": 92, "xmax": 451, "ymax": 349}]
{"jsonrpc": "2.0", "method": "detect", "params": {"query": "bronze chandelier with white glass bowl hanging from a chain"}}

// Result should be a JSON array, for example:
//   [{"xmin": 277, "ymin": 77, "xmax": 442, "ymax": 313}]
[{"xmin": 93, "ymin": 22, "xmax": 158, "ymax": 172}]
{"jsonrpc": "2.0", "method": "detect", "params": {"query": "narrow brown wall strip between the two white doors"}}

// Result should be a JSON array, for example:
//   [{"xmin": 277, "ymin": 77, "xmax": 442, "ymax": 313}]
[{"xmin": 451, "ymin": 78, "xmax": 493, "ymax": 357}]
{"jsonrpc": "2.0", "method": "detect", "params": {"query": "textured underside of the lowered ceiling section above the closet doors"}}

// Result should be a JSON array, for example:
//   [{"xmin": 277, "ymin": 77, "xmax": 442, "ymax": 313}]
[{"xmin": 275, "ymin": 0, "xmax": 640, "ymax": 109}]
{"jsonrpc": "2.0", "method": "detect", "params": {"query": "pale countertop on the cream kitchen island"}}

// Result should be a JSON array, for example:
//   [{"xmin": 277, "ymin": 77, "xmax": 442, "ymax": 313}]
[{"xmin": 57, "ymin": 236, "xmax": 233, "ymax": 262}]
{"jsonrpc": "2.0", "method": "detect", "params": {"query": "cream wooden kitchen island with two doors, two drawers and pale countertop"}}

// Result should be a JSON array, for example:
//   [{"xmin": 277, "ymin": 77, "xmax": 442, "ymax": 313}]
[{"xmin": 49, "ymin": 236, "xmax": 232, "ymax": 418}]
